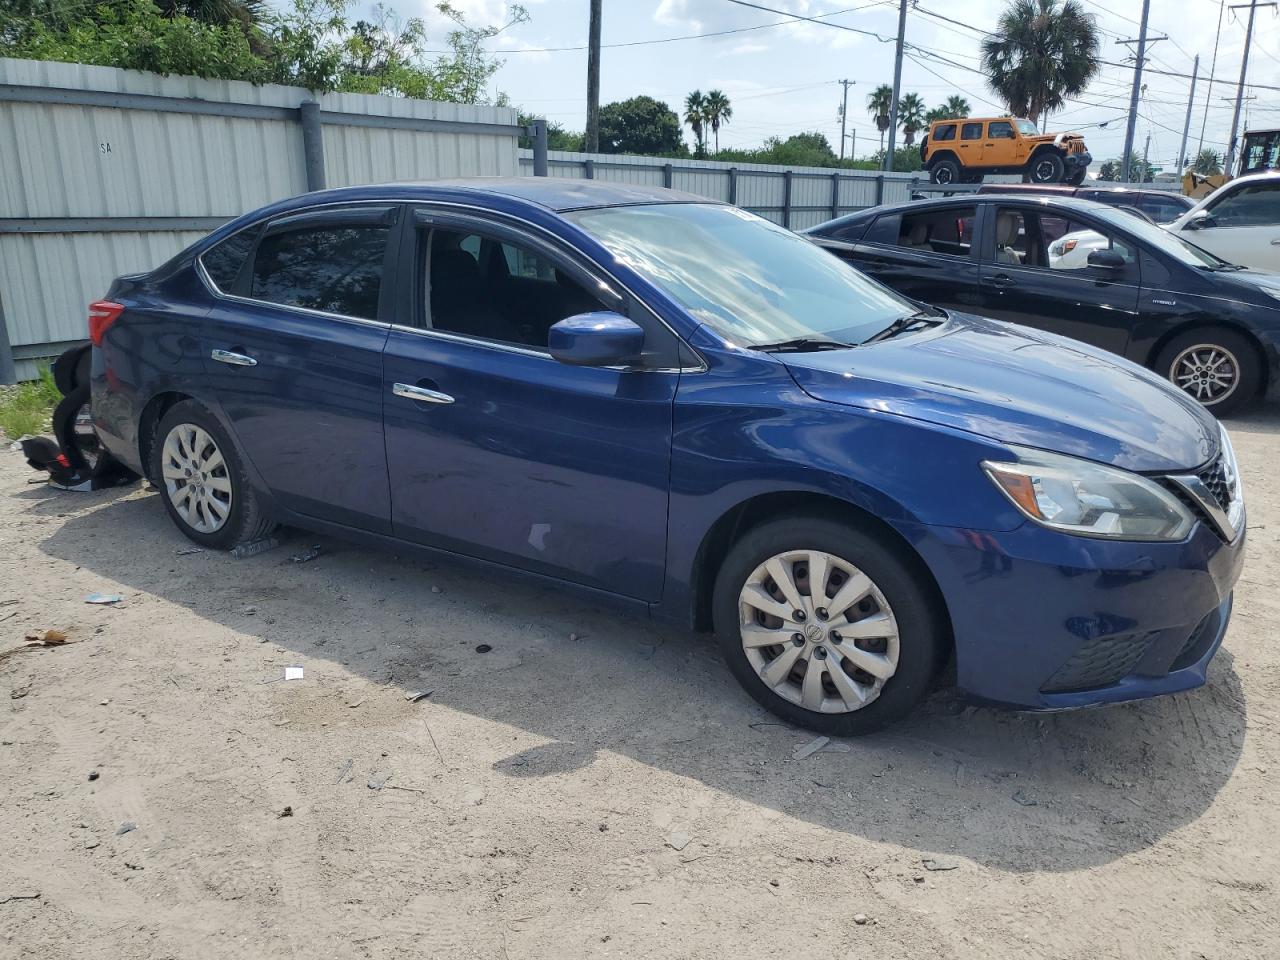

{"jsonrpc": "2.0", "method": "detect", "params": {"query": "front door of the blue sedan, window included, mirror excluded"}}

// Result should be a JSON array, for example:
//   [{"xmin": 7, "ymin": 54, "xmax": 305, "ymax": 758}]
[{"xmin": 383, "ymin": 211, "xmax": 680, "ymax": 600}]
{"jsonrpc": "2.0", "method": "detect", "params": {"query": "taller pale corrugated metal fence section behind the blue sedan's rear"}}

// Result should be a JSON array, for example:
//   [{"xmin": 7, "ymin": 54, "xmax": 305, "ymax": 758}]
[{"xmin": 0, "ymin": 59, "xmax": 524, "ymax": 383}]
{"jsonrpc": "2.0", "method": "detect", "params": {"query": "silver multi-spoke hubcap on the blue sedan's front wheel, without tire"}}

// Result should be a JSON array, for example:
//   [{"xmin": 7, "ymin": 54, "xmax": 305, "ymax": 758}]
[{"xmin": 737, "ymin": 550, "xmax": 900, "ymax": 713}]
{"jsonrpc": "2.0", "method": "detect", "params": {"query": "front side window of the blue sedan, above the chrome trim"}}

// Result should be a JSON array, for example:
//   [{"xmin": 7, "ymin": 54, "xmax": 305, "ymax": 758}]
[{"xmin": 420, "ymin": 229, "xmax": 607, "ymax": 348}]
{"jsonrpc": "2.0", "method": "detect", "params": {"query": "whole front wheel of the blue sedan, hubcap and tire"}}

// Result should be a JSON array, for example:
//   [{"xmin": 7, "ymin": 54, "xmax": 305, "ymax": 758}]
[{"xmin": 713, "ymin": 516, "xmax": 947, "ymax": 736}]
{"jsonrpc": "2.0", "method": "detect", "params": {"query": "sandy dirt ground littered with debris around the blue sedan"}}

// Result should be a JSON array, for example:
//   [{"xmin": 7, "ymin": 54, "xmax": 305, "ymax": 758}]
[{"xmin": 0, "ymin": 407, "xmax": 1280, "ymax": 960}]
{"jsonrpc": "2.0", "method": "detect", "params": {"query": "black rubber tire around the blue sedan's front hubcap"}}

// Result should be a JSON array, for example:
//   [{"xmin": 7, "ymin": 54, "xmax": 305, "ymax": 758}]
[{"xmin": 712, "ymin": 515, "xmax": 950, "ymax": 736}]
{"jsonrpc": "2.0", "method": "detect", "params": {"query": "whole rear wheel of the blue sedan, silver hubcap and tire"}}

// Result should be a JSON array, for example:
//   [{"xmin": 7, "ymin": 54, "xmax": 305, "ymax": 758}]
[{"xmin": 151, "ymin": 401, "xmax": 275, "ymax": 550}]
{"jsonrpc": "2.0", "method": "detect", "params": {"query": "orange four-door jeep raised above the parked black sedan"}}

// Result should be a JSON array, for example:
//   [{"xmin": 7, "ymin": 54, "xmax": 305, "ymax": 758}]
[{"xmin": 920, "ymin": 116, "xmax": 1093, "ymax": 184}]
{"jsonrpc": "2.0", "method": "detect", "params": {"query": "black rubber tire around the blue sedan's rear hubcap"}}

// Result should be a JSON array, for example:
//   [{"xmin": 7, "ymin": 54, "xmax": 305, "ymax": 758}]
[{"xmin": 148, "ymin": 401, "xmax": 275, "ymax": 550}]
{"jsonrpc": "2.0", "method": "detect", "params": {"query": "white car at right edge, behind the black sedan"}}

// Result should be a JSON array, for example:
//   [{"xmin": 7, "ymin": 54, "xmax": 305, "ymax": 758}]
[{"xmin": 1167, "ymin": 172, "xmax": 1280, "ymax": 273}]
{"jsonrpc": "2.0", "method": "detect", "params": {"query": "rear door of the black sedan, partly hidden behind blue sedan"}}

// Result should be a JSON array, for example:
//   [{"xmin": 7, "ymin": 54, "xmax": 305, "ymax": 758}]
[{"xmin": 832, "ymin": 205, "xmax": 980, "ymax": 310}]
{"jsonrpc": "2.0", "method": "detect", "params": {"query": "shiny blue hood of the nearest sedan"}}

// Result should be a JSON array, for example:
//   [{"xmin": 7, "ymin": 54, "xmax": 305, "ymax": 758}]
[{"xmin": 778, "ymin": 314, "xmax": 1219, "ymax": 472}]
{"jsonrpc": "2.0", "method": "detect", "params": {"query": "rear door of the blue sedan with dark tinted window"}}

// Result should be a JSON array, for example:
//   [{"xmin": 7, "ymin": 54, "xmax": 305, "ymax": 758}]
[{"xmin": 202, "ymin": 205, "xmax": 401, "ymax": 532}]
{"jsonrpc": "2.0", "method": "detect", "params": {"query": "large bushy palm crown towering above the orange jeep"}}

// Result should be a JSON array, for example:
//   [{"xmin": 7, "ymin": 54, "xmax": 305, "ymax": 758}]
[{"xmin": 982, "ymin": 0, "xmax": 1098, "ymax": 122}]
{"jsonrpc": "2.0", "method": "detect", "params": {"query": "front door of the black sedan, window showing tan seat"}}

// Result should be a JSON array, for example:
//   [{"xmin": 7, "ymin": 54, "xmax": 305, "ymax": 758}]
[{"xmin": 982, "ymin": 204, "xmax": 1140, "ymax": 353}]
